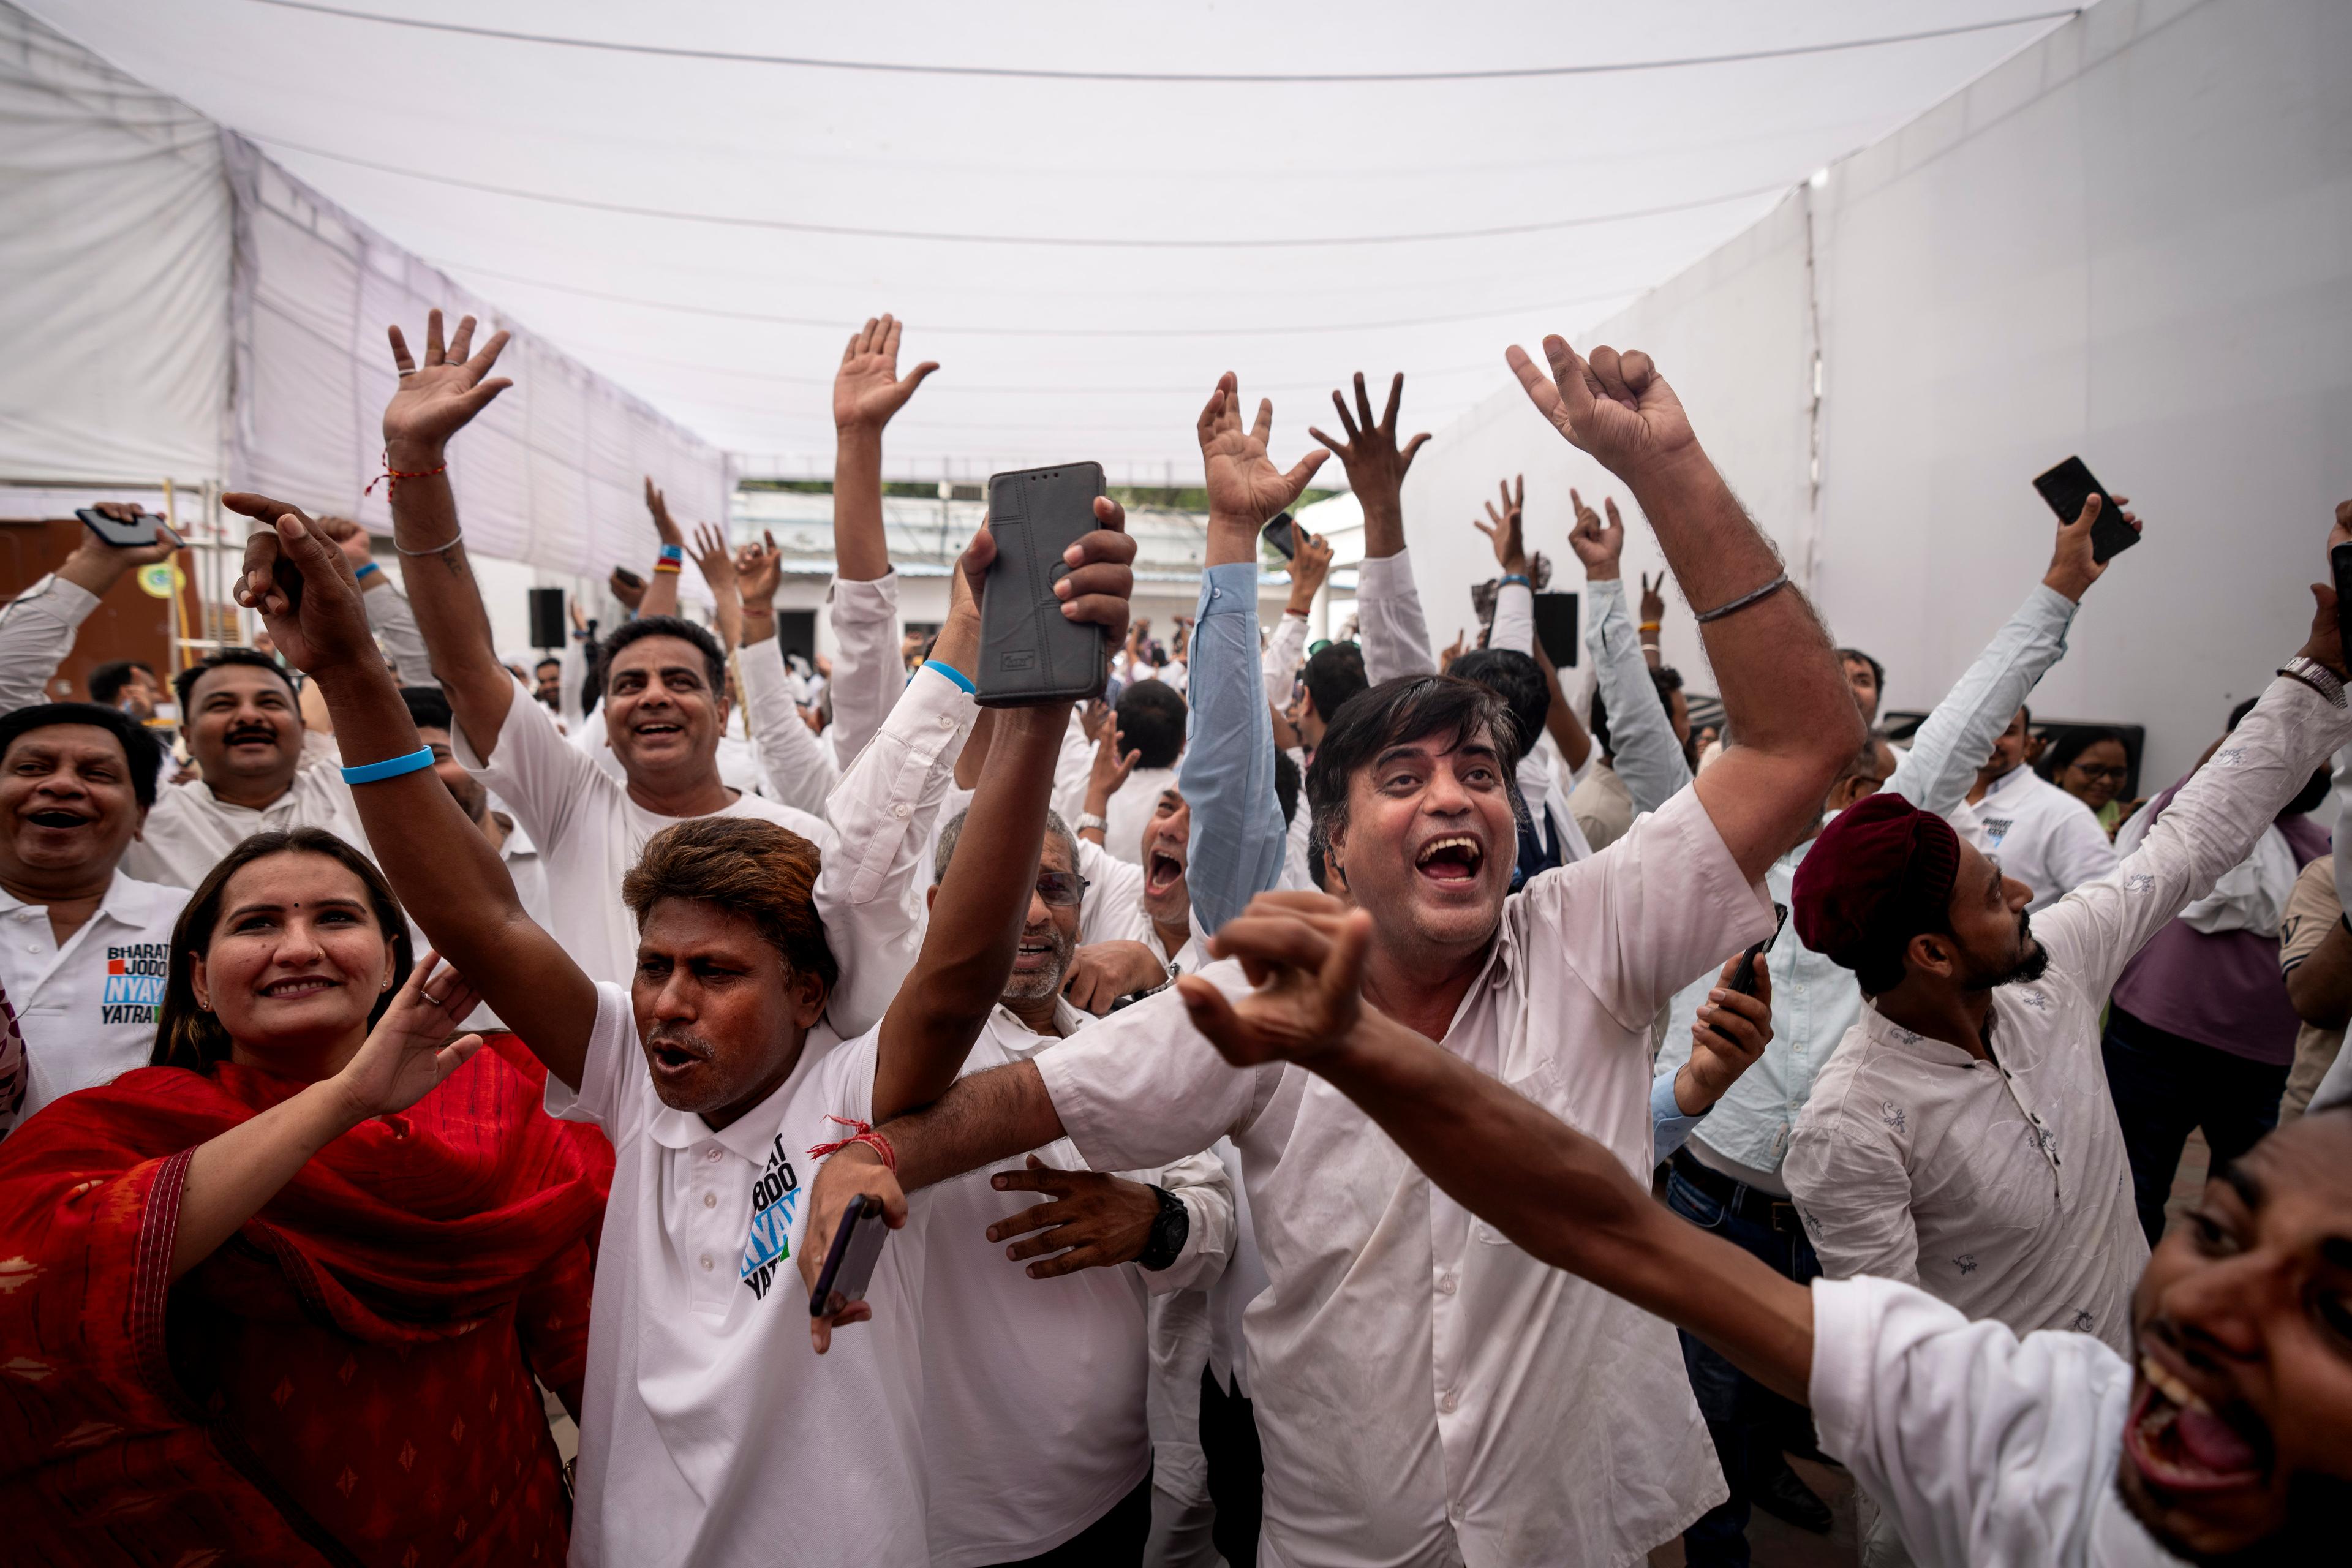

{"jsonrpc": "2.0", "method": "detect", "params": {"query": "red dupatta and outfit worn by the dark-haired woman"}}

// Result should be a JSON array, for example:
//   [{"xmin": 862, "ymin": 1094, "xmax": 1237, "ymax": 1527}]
[{"xmin": 0, "ymin": 1037, "xmax": 611, "ymax": 1566}]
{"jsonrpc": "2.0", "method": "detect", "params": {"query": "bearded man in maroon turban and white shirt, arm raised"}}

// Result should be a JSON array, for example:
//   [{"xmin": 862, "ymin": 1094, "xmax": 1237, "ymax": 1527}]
[{"xmin": 1778, "ymin": 510, "xmax": 2352, "ymax": 1476}]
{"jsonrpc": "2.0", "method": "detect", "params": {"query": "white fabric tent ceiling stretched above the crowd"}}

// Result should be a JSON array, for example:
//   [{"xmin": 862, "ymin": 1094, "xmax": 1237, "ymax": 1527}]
[{"xmin": 13, "ymin": 0, "xmax": 2070, "ymax": 484}]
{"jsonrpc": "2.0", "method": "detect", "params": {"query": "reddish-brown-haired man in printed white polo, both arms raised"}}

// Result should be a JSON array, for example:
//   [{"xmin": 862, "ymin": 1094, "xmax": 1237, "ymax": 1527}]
[{"xmin": 240, "ymin": 470, "xmax": 1134, "ymax": 1568}]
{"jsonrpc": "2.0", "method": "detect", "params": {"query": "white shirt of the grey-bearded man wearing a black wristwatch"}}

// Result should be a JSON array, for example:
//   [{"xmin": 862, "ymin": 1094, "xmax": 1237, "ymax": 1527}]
[{"xmin": 922, "ymin": 1001, "xmax": 1232, "ymax": 1568}]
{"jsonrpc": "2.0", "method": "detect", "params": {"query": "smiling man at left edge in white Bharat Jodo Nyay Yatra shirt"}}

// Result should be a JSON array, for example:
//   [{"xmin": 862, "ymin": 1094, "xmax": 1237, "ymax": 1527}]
[{"xmin": 0, "ymin": 703, "xmax": 188, "ymax": 1133}]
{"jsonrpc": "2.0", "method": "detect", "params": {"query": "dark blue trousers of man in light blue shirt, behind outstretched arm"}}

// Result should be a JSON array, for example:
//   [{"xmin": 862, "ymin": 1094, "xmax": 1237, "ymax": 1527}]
[{"xmin": 1665, "ymin": 1152, "xmax": 1820, "ymax": 1568}]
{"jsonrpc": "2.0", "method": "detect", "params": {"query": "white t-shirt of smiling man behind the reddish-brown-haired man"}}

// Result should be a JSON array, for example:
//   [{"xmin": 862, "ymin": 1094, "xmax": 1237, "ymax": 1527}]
[{"xmin": 449, "ymin": 682, "xmax": 849, "ymax": 985}]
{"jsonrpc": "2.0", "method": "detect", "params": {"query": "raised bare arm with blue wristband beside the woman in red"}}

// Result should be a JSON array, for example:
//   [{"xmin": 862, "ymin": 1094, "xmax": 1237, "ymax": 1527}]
[{"xmin": 221, "ymin": 494, "xmax": 597, "ymax": 1093}]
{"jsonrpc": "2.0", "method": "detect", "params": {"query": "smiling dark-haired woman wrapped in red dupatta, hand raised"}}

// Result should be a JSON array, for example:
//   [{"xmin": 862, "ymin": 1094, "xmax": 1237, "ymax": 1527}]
[{"xmin": 0, "ymin": 830, "xmax": 611, "ymax": 1568}]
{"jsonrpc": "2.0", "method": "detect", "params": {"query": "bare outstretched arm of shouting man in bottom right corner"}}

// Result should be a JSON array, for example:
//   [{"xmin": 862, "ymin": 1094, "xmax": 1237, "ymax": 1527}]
[{"xmin": 1176, "ymin": 893, "xmax": 1814, "ymax": 1403}]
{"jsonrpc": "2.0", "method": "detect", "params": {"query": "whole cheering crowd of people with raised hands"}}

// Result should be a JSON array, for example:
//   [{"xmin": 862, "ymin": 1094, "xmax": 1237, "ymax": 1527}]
[{"xmin": 0, "ymin": 312, "xmax": 2352, "ymax": 1568}]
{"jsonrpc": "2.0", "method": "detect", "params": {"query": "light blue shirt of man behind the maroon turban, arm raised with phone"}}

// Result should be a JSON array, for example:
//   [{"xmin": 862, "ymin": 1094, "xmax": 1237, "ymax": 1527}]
[{"xmin": 1656, "ymin": 586, "xmax": 2075, "ymax": 1170}]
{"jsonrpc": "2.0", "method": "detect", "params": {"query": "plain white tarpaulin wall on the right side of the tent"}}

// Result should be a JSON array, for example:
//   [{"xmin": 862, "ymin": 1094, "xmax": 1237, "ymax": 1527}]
[{"xmin": 1406, "ymin": 0, "xmax": 2352, "ymax": 790}]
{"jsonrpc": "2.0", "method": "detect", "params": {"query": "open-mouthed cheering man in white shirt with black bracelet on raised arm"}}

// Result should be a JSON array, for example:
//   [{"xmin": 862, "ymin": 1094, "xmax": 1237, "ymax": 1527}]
[{"xmin": 804, "ymin": 339, "xmax": 1863, "ymax": 1568}]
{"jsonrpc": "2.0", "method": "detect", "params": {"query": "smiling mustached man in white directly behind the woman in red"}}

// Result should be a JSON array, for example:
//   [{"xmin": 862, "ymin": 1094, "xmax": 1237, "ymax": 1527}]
[{"xmin": 108, "ymin": 649, "xmax": 367, "ymax": 889}]
